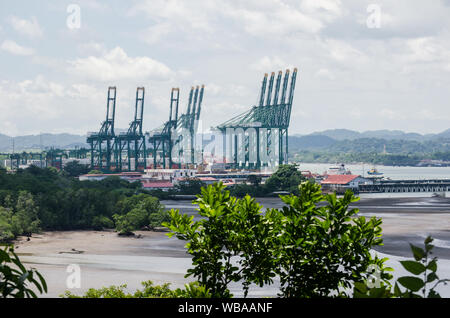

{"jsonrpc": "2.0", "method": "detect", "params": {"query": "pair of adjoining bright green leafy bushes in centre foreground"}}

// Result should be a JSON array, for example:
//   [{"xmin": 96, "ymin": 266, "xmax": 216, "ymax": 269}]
[{"xmin": 164, "ymin": 182, "xmax": 391, "ymax": 297}]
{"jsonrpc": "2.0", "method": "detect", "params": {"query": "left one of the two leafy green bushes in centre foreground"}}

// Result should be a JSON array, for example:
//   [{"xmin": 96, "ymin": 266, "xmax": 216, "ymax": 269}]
[{"xmin": 163, "ymin": 183, "xmax": 273, "ymax": 297}]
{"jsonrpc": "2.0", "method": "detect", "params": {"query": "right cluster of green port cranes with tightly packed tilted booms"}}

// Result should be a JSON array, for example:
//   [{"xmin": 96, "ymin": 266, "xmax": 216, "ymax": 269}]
[{"xmin": 216, "ymin": 68, "xmax": 297, "ymax": 170}]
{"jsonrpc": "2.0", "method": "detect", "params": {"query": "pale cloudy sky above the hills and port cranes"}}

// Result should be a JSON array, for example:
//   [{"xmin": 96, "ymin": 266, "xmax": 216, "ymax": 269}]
[{"xmin": 0, "ymin": 0, "xmax": 450, "ymax": 136}]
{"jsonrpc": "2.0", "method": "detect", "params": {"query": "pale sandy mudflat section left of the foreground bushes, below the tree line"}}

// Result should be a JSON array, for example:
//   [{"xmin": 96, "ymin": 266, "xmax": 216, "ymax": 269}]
[{"xmin": 16, "ymin": 231, "xmax": 191, "ymax": 297}]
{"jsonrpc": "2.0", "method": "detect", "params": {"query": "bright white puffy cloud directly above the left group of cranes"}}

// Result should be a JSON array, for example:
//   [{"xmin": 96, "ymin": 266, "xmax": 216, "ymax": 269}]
[{"xmin": 68, "ymin": 47, "xmax": 173, "ymax": 81}]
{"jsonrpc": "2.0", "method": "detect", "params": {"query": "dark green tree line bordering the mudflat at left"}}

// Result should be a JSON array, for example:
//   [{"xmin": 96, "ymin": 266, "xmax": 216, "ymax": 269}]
[{"xmin": 0, "ymin": 166, "xmax": 167, "ymax": 241}]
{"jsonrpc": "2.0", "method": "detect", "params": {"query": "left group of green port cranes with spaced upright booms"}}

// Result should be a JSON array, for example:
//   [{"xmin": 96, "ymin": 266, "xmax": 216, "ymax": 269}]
[{"xmin": 83, "ymin": 86, "xmax": 204, "ymax": 173}]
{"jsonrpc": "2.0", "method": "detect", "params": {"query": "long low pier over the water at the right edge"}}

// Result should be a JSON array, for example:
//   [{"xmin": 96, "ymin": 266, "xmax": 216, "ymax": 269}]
[{"xmin": 358, "ymin": 179, "xmax": 450, "ymax": 193}]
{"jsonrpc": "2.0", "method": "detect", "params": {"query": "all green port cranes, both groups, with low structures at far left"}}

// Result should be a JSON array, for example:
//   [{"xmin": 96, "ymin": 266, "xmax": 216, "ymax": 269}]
[{"xmin": 3, "ymin": 69, "xmax": 297, "ymax": 174}]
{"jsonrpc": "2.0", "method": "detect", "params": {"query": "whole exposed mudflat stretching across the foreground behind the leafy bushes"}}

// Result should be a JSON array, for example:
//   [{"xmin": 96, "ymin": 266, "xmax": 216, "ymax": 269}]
[{"xmin": 10, "ymin": 198, "xmax": 450, "ymax": 297}]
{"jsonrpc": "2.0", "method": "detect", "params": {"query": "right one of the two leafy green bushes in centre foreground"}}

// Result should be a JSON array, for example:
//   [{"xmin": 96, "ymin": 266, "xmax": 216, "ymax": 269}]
[{"xmin": 267, "ymin": 182, "xmax": 390, "ymax": 297}]
